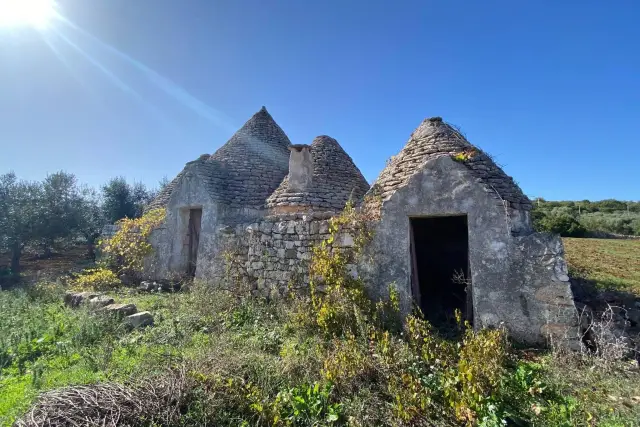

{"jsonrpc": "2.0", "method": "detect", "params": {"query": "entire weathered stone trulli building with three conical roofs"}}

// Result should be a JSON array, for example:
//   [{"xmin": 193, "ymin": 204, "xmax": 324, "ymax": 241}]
[{"xmin": 148, "ymin": 107, "xmax": 577, "ymax": 343}]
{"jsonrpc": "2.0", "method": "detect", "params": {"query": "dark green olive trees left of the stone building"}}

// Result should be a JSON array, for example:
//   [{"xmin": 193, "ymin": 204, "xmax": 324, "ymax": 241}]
[{"xmin": 0, "ymin": 171, "xmax": 167, "ymax": 279}]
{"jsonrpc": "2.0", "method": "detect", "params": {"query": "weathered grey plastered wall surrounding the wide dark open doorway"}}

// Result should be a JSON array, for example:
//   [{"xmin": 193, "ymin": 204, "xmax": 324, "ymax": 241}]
[{"xmin": 360, "ymin": 157, "xmax": 575, "ymax": 343}]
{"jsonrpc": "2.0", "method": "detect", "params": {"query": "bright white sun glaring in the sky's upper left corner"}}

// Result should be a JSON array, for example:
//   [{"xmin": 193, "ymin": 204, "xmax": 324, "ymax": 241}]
[{"xmin": 0, "ymin": 0, "xmax": 56, "ymax": 30}]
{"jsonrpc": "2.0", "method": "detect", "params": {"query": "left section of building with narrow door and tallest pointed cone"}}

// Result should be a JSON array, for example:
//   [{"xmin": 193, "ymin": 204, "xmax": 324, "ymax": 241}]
[{"xmin": 148, "ymin": 107, "xmax": 291, "ymax": 278}]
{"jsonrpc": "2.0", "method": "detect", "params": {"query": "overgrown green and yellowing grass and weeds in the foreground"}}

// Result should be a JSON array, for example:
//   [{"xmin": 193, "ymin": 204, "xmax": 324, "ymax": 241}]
[{"xmin": 0, "ymin": 284, "xmax": 640, "ymax": 426}]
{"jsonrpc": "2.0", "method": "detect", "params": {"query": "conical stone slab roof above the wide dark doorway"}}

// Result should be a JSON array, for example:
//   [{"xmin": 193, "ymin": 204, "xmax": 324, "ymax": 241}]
[{"xmin": 369, "ymin": 117, "xmax": 531, "ymax": 210}]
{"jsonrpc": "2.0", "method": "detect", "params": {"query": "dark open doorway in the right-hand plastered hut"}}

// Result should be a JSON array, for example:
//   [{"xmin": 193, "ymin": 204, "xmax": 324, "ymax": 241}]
[{"xmin": 411, "ymin": 215, "xmax": 473, "ymax": 327}]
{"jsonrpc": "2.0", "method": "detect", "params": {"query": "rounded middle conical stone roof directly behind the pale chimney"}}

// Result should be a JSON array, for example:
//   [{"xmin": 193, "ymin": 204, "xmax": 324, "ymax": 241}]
[{"xmin": 267, "ymin": 135, "xmax": 369, "ymax": 212}]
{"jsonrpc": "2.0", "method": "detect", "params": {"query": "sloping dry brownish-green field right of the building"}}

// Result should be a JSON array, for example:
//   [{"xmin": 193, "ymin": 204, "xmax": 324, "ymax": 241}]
[{"xmin": 563, "ymin": 238, "xmax": 640, "ymax": 295}]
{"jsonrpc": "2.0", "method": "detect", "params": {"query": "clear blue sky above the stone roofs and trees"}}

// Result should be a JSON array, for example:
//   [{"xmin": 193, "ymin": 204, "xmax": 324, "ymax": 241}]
[{"xmin": 0, "ymin": 0, "xmax": 640, "ymax": 200}]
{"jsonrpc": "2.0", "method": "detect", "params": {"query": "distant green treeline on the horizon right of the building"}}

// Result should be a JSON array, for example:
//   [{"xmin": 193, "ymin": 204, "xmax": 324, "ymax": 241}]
[{"xmin": 531, "ymin": 198, "xmax": 640, "ymax": 237}]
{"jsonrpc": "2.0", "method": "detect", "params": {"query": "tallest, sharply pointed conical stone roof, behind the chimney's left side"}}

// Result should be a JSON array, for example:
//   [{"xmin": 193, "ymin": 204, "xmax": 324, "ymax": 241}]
[{"xmin": 149, "ymin": 107, "xmax": 291, "ymax": 208}]
